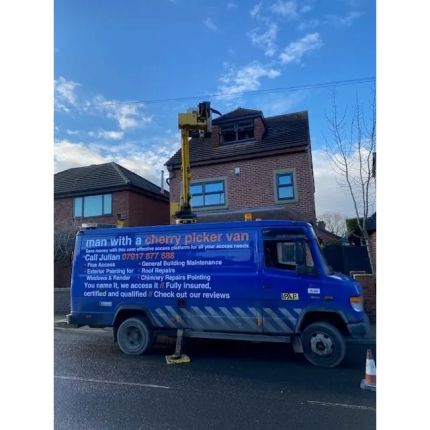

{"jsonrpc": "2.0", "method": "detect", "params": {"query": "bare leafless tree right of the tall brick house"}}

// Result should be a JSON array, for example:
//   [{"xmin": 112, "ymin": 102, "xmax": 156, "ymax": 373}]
[{"xmin": 326, "ymin": 92, "xmax": 376, "ymax": 272}]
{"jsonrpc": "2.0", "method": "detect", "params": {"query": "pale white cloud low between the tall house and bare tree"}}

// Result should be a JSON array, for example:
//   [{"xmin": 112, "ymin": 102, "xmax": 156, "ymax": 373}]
[{"xmin": 312, "ymin": 149, "xmax": 375, "ymax": 218}]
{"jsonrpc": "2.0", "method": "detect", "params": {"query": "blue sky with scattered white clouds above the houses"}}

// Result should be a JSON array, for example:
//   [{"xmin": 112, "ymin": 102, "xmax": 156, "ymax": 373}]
[{"xmin": 54, "ymin": 0, "xmax": 376, "ymax": 216}]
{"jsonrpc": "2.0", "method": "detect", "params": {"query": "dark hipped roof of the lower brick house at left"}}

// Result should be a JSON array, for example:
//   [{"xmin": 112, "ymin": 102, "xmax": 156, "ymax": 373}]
[{"xmin": 54, "ymin": 162, "xmax": 168, "ymax": 199}]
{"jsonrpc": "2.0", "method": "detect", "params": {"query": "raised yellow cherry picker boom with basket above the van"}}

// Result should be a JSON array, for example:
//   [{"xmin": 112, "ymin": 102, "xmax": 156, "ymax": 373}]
[{"xmin": 174, "ymin": 102, "xmax": 221, "ymax": 224}]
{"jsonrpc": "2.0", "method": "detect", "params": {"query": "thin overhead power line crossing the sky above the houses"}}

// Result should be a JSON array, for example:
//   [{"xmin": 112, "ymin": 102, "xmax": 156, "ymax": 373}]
[{"xmin": 61, "ymin": 76, "xmax": 375, "ymax": 109}]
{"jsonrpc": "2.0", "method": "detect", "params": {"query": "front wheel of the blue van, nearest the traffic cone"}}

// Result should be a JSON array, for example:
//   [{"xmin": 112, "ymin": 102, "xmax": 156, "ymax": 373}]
[{"xmin": 301, "ymin": 322, "xmax": 346, "ymax": 367}]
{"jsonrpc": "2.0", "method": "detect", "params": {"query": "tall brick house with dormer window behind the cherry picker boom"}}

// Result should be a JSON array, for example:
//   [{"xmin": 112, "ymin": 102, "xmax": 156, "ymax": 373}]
[{"xmin": 166, "ymin": 108, "xmax": 316, "ymax": 225}]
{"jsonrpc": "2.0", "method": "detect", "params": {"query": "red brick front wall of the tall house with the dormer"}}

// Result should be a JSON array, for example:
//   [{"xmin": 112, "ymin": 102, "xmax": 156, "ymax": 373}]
[{"xmin": 170, "ymin": 150, "xmax": 316, "ymax": 222}]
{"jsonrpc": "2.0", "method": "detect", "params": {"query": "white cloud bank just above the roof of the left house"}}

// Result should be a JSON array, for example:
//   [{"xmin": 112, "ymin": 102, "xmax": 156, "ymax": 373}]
[{"xmin": 54, "ymin": 135, "xmax": 180, "ymax": 185}]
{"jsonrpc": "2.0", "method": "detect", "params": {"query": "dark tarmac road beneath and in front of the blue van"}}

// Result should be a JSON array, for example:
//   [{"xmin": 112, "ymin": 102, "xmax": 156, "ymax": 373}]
[{"xmin": 54, "ymin": 328, "xmax": 376, "ymax": 430}]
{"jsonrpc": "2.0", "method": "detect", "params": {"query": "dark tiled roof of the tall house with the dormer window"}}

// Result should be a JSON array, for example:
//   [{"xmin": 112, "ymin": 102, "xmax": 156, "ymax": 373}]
[{"xmin": 166, "ymin": 108, "xmax": 310, "ymax": 167}]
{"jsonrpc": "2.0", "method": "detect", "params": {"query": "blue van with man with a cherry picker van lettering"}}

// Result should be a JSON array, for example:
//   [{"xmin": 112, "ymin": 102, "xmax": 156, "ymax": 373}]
[{"xmin": 67, "ymin": 221, "xmax": 369, "ymax": 367}]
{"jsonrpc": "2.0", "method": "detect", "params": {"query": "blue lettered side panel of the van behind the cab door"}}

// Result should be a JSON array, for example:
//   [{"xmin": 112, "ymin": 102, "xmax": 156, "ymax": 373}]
[{"xmin": 72, "ymin": 226, "xmax": 262, "ymax": 333}]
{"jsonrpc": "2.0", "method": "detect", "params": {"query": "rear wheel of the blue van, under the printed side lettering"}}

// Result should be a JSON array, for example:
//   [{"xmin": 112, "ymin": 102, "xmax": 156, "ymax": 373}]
[{"xmin": 117, "ymin": 317, "xmax": 153, "ymax": 355}]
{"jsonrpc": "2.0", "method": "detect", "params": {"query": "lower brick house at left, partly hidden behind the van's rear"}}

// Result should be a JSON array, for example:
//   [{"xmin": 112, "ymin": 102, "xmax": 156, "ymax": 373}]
[{"xmin": 54, "ymin": 162, "xmax": 170, "ymax": 287}]
